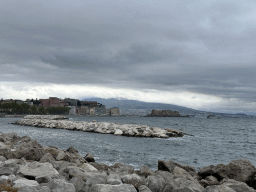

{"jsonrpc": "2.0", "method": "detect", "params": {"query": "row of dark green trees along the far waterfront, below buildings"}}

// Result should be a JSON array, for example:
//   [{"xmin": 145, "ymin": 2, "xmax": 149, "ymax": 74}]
[{"xmin": 0, "ymin": 102, "xmax": 70, "ymax": 115}]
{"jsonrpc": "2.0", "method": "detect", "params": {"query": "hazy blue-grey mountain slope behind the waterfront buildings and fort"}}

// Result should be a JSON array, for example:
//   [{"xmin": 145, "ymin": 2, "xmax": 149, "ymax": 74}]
[{"xmin": 85, "ymin": 98, "xmax": 205, "ymax": 116}]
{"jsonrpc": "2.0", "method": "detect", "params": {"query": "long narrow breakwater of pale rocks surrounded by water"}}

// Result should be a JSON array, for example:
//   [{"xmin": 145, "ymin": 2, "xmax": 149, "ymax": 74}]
[{"xmin": 15, "ymin": 115, "xmax": 188, "ymax": 138}]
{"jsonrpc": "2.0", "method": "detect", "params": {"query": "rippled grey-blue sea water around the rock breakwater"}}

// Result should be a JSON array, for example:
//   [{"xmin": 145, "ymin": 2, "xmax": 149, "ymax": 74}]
[{"xmin": 0, "ymin": 116, "xmax": 256, "ymax": 169}]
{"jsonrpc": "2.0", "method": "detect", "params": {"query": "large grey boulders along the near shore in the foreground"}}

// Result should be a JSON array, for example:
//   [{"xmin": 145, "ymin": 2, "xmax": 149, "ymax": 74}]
[{"xmin": 0, "ymin": 133, "xmax": 256, "ymax": 192}]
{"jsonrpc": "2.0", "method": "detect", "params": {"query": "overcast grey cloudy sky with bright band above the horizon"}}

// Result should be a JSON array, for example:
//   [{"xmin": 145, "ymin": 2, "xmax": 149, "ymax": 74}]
[{"xmin": 0, "ymin": 0, "xmax": 256, "ymax": 115}]
